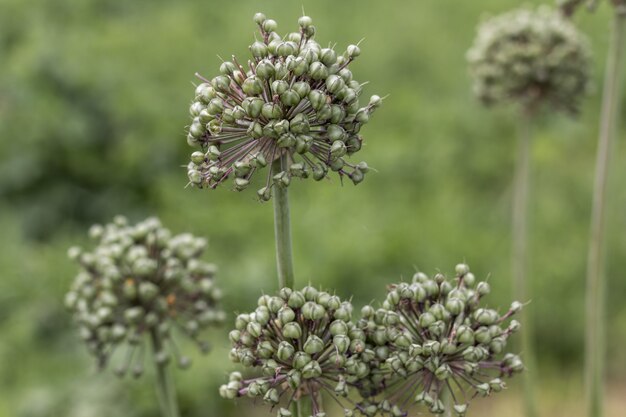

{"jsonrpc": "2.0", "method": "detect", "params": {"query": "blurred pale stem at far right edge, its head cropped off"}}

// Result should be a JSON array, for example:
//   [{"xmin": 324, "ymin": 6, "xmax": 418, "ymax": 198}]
[{"xmin": 585, "ymin": 13, "xmax": 626, "ymax": 417}]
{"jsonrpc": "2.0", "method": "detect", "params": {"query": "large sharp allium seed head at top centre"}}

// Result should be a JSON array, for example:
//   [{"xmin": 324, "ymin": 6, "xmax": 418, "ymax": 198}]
[{"xmin": 187, "ymin": 13, "xmax": 382, "ymax": 201}]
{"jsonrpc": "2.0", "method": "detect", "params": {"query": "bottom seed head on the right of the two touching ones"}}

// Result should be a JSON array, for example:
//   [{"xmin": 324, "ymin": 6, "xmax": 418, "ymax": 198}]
[{"xmin": 358, "ymin": 264, "xmax": 524, "ymax": 417}]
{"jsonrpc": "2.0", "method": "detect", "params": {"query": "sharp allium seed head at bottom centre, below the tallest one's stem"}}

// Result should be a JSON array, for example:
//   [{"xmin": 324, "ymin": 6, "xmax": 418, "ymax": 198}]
[{"xmin": 220, "ymin": 286, "xmax": 373, "ymax": 417}]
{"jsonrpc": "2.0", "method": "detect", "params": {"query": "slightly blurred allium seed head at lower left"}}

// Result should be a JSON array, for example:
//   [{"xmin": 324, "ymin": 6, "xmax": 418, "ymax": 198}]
[{"xmin": 65, "ymin": 216, "xmax": 224, "ymax": 376}]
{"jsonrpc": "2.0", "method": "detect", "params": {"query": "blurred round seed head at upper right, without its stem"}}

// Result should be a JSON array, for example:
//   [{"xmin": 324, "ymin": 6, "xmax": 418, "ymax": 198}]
[{"xmin": 467, "ymin": 7, "xmax": 590, "ymax": 112}]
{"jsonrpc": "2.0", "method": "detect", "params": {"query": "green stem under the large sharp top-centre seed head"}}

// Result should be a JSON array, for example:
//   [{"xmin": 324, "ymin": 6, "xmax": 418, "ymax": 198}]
[{"xmin": 272, "ymin": 156, "xmax": 294, "ymax": 288}]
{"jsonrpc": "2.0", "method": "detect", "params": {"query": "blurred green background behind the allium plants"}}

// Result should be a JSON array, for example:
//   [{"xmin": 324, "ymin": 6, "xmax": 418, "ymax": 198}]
[{"xmin": 0, "ymin": 0, "xmax": 626, "ymax": 417}]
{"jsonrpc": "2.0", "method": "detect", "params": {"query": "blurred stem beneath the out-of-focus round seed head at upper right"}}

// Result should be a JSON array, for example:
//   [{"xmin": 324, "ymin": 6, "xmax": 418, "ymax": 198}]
[{"xmin": 511, "ymin": 109, "xmax": 538, "ymax": 417}]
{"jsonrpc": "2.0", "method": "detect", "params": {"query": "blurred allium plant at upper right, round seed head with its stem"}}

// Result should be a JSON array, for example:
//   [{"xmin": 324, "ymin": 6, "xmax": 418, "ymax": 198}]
[{"xmin": 467, "ymin": 6, "xmax": 590, "ymax": 417}]
